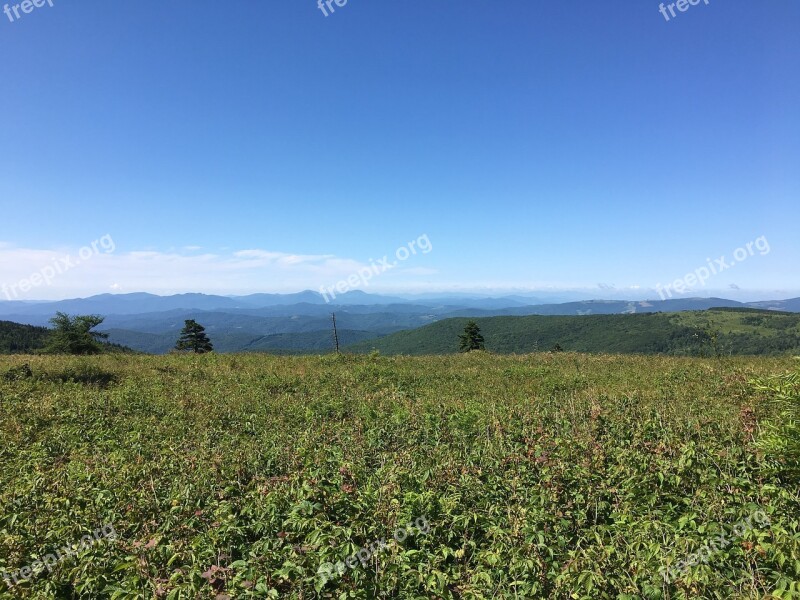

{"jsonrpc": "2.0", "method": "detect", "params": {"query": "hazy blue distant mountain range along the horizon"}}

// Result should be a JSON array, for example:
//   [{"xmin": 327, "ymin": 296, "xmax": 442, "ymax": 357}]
[{"xmin": 0, "ymin": 291, "xmax": 800, "ymax": 353}]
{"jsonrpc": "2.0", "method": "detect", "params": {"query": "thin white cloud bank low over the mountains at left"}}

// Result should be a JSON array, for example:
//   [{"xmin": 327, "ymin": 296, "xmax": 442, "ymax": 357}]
[{"xmin": 0, "ymin": 243, "xmax": 434, "ymax": 300}]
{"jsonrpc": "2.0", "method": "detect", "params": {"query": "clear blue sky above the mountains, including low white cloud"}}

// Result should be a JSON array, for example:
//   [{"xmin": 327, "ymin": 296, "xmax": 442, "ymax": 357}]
[{"xmin": 0, "ymin": 0, "xmax": 800, "ymax": 299}]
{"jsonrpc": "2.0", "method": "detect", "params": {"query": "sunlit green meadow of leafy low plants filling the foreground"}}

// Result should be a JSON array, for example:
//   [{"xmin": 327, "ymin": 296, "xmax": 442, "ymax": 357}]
[{"xmin": 0, "ymin": 353, "xmax": 800, "ymax": 600}]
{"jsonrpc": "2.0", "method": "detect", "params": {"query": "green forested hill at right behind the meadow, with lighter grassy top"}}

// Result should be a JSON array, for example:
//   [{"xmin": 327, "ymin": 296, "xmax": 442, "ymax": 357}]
[{"xmin": 346, "ymin": 309, "xmax": 800, "ymax": 356}]
